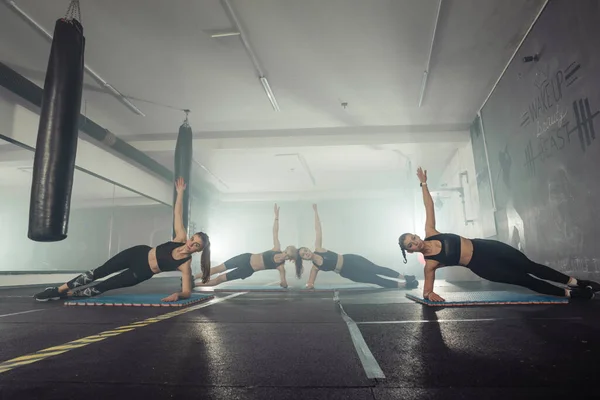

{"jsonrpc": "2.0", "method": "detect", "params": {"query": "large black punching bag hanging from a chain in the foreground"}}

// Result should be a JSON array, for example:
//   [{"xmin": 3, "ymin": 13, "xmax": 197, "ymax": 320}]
[{"xmin": 27, "ymin": 19, "xmax": 85, "ymax": 242}]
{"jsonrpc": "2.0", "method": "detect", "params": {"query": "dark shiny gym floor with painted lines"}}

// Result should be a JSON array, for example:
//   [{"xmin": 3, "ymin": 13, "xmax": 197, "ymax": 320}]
[{"xmin": 0, "ymin": 278, "xmax": 600, "ymax": 400}]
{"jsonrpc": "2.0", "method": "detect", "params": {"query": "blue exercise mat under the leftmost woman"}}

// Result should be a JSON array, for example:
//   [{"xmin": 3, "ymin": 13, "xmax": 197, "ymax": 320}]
[{"xmin": 65, "ymin": 294, "xmax": 214, "ymax": 307}]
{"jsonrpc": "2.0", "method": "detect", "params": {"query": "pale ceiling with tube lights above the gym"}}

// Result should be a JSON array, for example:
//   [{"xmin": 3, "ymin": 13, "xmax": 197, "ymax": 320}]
[{"xmin": 0, "ymin": 0, "xmax": 544, "ymax": 198}]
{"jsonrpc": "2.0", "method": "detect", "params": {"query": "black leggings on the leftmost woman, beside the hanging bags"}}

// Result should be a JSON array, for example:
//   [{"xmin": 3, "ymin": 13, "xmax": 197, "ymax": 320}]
[{"xmin": 67, "ymin": 245, "xmax": 154, "ymax": 295}]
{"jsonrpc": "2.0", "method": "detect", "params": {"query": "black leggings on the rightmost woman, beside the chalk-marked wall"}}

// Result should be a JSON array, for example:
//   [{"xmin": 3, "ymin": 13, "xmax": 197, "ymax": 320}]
[{"xmin": 467, "ymin": 239, "xmax": 570, "ymax": 297}]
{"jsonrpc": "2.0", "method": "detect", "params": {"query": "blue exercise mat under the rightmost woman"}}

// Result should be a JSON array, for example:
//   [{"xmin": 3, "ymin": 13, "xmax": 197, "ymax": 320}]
[{"xmin": 406, "ymin": 291, "xmax": 569, "ymax": 307}]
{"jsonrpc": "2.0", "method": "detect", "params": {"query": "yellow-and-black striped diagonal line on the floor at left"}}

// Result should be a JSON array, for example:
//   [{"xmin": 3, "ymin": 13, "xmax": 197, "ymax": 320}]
[{"xmin": 0, "ymin": 292, "xmax": 246, "ymax": 374}]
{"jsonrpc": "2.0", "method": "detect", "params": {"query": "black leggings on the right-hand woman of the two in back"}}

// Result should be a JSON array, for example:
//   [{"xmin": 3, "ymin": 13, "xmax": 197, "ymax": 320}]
[{"xmin": 340, "ymin": 254, "xmax": 400, "ymax": 288}]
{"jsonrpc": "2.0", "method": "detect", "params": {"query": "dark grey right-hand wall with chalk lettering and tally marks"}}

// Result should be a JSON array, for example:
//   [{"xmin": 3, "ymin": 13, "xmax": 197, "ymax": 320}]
[{"xmin": 478, "ymin": 0, "xmax": 600, "ymax": 278}]
